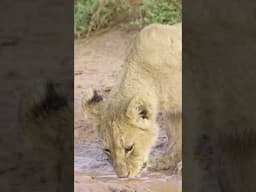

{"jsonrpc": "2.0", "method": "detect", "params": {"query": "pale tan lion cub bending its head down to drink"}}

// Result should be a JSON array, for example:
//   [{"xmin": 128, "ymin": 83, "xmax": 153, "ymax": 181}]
[{"xmin": 82, "ymin": 24, "xmax": 182, "ymax": 177}]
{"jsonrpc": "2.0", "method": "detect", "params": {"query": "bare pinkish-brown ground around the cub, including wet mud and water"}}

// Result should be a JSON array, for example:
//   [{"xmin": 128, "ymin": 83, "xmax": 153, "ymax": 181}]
[{"xmin": 74, "ymin": 29, "xmax": 181, "ymax": 192}]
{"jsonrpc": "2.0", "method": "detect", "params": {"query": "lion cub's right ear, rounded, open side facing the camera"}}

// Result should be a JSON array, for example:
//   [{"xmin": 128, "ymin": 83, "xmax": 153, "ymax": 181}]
[{"xmin": 126, "ymin": 94, "xmax": 157, "ymax": 128}]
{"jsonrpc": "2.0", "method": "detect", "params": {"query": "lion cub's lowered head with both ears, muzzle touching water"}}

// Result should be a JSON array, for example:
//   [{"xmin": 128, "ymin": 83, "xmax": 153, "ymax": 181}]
[{"xmin": 82, "ymin": 89, "xmax": 158, "ymax": 177}]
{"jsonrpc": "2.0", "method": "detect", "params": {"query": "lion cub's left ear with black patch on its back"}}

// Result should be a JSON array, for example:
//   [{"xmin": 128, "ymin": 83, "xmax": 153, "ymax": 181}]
[{"xmin": 82, "ymin": 89, "xmax": 103, "ymax": 119}]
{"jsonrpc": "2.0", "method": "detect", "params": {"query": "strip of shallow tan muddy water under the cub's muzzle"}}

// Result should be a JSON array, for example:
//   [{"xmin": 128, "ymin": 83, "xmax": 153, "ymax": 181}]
[{"xmin": 75, "ymin": 174, "xmax": 181, "ymax": 192}]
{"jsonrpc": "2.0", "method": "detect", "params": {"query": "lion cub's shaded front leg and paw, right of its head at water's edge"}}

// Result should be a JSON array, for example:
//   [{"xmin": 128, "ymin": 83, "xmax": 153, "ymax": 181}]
[{"xmin": 149, "ymin": 113, "xmax": 182, "ymax": 175}]
